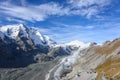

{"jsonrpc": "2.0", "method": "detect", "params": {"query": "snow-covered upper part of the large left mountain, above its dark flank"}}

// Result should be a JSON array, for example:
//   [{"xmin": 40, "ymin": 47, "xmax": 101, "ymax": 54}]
[{"xmin": 0, "ymin": 24, "xmax": 56, "ymax": 46}]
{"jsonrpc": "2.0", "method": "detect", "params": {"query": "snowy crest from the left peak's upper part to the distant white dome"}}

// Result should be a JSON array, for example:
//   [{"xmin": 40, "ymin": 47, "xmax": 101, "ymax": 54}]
[{"xmin": 0, "ymin": 24, "xmax": 89, "ymax": 49}]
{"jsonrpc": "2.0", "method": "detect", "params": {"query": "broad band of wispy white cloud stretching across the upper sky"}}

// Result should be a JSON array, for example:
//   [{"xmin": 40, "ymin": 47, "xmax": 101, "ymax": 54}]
[{"xmin": 0, "ymin": 0, "xmax": 111, "ymax": 22}]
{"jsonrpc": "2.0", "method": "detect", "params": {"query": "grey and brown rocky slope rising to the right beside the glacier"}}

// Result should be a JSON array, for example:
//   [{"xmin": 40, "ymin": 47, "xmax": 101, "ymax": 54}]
[{"xmin": 62, "ymin": 38, "xmax": 120, "ymax": 80}]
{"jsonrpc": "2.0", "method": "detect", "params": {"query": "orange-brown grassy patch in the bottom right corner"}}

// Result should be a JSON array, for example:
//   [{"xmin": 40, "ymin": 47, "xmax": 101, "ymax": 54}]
[{"xmin": 96, "ymin": 58, "xmax": 120, "ymax": 80}]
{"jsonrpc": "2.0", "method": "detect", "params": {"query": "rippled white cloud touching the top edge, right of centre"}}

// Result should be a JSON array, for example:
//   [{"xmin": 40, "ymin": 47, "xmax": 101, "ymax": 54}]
[{"xmin": 67, "ymin": 0, "xmax": 111, "ymax": 19}]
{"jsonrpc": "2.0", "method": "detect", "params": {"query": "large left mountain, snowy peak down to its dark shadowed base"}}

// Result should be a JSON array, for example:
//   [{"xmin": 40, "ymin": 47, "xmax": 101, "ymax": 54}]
[{"xmin": 0, "ymin": 24, "xmax": 59, "ymax": 67}]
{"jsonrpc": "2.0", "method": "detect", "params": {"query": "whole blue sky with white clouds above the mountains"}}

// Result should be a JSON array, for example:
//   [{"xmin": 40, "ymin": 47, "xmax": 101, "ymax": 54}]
[{"xmin": 0, "ymin": 0, "xmax": 120, "ymax": 43}]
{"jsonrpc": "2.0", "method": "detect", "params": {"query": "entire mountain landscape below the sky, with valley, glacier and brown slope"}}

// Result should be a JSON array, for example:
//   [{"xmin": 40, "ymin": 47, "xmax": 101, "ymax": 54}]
[{"xmin": 0, "ymin": 24, "xmax": 120, "ymax": 80}]
